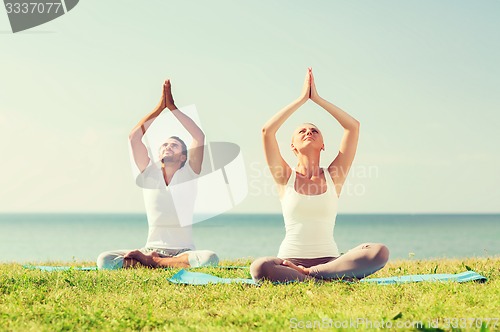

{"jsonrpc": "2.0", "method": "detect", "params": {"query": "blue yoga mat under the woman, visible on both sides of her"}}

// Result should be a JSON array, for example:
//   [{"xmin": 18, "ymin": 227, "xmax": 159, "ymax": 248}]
[{"xmin": 168, "ymin": 270, "xmax": 487, "ymax": 285}]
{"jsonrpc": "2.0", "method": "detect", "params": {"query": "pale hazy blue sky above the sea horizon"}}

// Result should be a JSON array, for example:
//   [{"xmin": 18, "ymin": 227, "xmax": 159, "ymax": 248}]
[{"xmin": 0, "ymin": 0, "xmax": 500, "ymax": 213}]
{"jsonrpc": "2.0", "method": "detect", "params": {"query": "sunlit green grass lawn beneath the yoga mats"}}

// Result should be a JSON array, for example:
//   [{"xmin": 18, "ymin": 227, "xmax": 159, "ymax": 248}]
[{"xmin": 0, "ymin": 258, "xmax": 500, "ymax": 331}]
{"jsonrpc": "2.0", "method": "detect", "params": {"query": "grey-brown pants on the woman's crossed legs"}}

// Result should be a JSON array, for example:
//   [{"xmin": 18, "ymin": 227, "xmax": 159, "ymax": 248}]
[{"xmin": 250, "ymin": 243, "xmax": 389, "ymax": 282}]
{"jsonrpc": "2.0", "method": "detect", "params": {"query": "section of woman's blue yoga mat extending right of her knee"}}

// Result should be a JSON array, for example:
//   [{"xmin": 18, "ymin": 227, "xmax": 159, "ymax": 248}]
[{"xmin": 360, "ymin": 271, "xmax": 488, "ymax": 285}]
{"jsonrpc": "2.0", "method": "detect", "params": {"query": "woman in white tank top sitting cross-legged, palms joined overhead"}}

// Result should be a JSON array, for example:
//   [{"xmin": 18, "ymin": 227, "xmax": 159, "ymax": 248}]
[{"xmin": 250, "ymin": 68, "xmax": 389, "ymax": 282}]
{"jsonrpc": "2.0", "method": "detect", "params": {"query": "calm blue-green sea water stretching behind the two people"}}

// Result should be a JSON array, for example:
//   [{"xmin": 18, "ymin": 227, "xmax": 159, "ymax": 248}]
[{"xmin": 0, "ymin": 214, "xmax": 500, "ymax": 263}]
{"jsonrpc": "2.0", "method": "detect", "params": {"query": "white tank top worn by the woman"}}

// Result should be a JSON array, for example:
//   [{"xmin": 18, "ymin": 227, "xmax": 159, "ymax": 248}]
[{"xmin": 278, "ymin": 168, "xmax": 339, "ymax": 258}]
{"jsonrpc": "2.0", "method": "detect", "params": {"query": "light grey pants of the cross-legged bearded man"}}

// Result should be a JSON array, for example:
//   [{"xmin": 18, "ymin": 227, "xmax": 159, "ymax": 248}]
[{"xmin": 97, "ymin": 248, "xmax": 219, "ymax": 270}]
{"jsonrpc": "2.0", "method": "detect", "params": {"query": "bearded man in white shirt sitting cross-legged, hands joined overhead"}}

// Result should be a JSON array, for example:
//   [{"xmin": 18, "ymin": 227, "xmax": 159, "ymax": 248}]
[{"xmin": 97, "ymin": 80, "xmax": 219, "ymax": 269}]
